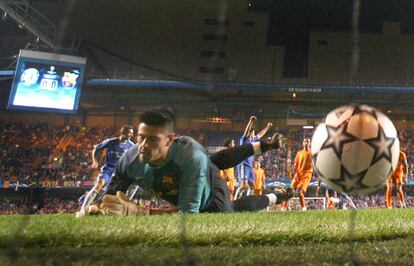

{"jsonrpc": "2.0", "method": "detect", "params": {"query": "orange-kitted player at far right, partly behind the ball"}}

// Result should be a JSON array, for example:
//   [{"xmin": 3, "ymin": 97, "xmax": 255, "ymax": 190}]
[{"xmin": 385, "ymin": 151, "xmax": 408, "ymax": 209}]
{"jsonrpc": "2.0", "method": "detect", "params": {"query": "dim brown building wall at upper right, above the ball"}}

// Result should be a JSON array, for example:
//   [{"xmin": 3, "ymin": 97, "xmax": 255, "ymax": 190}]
[{"xmin": 308, "ymin": 22, "xmax": 414, "ymax": 84}]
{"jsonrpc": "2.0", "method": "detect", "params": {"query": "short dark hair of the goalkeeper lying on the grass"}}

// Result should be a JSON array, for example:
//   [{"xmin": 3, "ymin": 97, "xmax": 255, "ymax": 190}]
[{"xmin": 139, "ymin": 109, "xmax": 175, "ymax": 132}]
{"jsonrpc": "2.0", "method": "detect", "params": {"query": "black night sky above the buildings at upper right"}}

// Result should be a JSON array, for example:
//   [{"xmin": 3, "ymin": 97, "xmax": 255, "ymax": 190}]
[{"xmin": 258, "ymin": 0, "xmax": 414, "ymax": 77}]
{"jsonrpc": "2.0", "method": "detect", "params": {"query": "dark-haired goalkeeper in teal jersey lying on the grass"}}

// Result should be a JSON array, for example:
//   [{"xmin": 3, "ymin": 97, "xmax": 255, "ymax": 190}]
[{"xmin": 77, "ymin": 109, "xmax": 293, "ymax": 216}]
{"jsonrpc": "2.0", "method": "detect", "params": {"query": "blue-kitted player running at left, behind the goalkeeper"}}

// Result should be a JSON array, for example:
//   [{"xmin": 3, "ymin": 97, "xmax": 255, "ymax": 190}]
[{"xmin": 81, "ymin": 125, "xmax": 134, "ymax": 212}]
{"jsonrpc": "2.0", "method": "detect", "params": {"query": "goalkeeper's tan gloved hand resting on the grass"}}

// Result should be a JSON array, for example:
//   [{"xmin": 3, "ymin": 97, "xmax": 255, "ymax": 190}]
[{"xmin": 101, "ymin": 191, "xmax": 150, "ymax": 216}]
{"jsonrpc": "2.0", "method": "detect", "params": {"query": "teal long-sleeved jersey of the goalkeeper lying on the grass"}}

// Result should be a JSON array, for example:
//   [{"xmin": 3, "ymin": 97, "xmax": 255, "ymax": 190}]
[{"xmin": 105, "ymin": 136, "xmax": 215, "ymax": 212}]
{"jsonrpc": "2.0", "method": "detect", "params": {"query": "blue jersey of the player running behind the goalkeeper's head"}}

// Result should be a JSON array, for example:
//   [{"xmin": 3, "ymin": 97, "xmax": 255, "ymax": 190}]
[{"xmin": 95, "ymin": 138, "xmax": 134, "ymax": 172}]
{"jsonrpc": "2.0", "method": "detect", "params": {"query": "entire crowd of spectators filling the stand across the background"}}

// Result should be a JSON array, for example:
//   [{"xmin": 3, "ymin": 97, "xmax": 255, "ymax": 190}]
[{"xmin": 0, "ymin": 121, "xmax": 414, "ymax": 206}]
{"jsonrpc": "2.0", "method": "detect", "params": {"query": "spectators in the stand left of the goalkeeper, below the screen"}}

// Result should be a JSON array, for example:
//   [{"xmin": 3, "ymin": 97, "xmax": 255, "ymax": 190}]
[{"xmin": 0, "ymin": 121, "xmax": 119, "ymax": 184}]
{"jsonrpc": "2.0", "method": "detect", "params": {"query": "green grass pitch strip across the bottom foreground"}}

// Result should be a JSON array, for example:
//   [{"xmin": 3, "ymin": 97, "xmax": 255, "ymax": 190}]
[{"xmin": 0, "ymin": 209, "xmax": 414, "ymax": 265}]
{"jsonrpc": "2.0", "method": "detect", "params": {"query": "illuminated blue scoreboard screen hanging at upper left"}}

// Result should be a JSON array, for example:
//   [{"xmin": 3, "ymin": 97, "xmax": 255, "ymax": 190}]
[{"xmin": 7, "ymin": 50, "xmax": 86, "ymax": 113}]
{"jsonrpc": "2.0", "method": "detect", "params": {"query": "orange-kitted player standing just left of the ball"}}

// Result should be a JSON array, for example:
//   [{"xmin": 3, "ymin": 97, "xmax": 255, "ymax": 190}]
[{"xmin": 282, "ymin": 138, "xmax": 313, "ymax": 211}]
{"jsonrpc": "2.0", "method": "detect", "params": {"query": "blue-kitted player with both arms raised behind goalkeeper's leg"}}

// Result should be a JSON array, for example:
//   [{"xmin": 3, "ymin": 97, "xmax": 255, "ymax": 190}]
[{"xmin": 234, "ymin": 116, "xmax": 272, "ymax": 199}]
